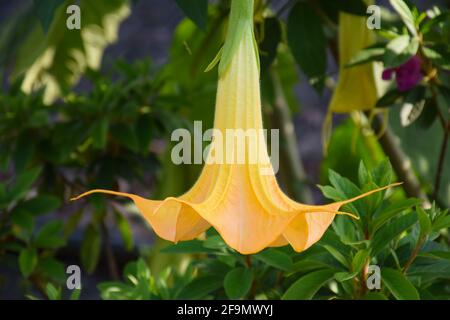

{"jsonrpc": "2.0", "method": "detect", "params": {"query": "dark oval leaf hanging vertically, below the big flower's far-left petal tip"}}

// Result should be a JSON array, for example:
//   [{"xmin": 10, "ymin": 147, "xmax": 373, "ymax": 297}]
[{"xmin": 80, "ymin": 224, "xmax": 102, "ymax": 273}]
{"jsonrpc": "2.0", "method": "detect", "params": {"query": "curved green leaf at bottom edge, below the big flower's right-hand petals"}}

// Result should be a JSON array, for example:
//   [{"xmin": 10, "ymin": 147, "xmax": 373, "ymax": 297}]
[{"xmin": 282, "ymin": 269, "xmax": 335, "ymax": 300}]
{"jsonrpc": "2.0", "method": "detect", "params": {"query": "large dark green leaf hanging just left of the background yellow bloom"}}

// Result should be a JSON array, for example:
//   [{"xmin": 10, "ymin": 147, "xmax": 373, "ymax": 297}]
[{"xmin": 287, "ymin": 2, "xmax": 327, "ymax": 90}]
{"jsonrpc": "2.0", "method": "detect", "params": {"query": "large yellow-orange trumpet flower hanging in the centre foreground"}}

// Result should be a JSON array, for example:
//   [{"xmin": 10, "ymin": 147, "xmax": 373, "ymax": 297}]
[{"xmin": 74, "ymin": 0, "xmax": 400, "ymax": 254}]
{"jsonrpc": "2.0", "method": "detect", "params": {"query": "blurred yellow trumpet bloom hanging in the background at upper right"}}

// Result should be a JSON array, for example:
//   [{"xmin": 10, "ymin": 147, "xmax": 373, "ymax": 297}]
[{"xmin": 330, "ymin": 5, "xmax": 377, "ymax": 113}]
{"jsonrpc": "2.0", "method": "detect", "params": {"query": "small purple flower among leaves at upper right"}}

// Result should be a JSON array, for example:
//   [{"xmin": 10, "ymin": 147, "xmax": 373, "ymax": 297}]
[{"xmin": 381, "ymin": 56, "xmax": 422, "ymax": 92}]
